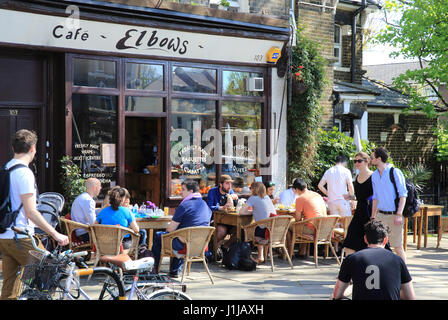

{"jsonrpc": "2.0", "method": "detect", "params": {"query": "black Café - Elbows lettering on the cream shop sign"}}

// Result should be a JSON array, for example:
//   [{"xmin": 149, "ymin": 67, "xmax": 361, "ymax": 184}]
[{"xmin": 53, "ymin": 25, "xmax": 189, "ymax": 54}]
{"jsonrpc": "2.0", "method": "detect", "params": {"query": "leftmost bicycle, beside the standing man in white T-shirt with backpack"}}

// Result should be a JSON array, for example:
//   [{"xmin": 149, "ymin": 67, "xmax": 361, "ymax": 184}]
[{"xmin": 13, "ymin": 227, "xmax": 126, "ymax": 300}]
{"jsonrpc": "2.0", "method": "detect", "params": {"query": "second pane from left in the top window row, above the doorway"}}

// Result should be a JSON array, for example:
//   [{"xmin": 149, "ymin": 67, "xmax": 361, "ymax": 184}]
[{"xmin": 126, "ymin": 63, "xmax": 164, "ymax": 90}]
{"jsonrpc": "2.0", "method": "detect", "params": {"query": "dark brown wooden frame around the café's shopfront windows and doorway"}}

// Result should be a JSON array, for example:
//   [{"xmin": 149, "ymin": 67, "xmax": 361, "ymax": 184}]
[{"xmin": 65, "ymin": 53, "xmax": 272, "ymax": 205}]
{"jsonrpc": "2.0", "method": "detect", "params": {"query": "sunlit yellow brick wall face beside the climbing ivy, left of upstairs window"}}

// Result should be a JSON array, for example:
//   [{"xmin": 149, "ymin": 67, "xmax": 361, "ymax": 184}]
[{"xmin": 296, "ymin": 5, "xmax": 334, "ymax": 129}]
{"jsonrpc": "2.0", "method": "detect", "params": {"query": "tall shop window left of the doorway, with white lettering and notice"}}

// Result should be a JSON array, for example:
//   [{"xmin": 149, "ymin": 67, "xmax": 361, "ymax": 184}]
[{"xmin": 72, "ymin": 94, "xmax": 117, "ymax": 193}]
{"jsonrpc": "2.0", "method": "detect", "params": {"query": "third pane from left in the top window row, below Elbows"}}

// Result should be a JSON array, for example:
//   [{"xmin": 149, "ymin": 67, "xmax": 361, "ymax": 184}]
[{"xmin": 172, "ymin": 67, "xmax": 216, "ymax": 93}]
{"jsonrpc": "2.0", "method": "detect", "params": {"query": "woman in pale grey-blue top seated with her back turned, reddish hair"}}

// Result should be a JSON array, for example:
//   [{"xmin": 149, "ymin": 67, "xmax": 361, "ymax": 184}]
[{"xmin": 239, "ymin": 182, "xmax": 277, "ymax": 263}]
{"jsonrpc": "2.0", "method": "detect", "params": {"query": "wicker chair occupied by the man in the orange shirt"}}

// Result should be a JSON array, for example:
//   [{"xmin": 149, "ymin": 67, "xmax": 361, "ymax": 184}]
[{"xmin": 289, "ymin": 216, "xmax": 341, "ymax": 268}]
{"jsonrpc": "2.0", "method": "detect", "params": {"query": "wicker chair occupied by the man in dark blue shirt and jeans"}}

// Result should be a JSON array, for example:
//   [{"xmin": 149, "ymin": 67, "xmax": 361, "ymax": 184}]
[{"xmin": 158, "ymin": 227, "xmax": 215, "ymax": 284}]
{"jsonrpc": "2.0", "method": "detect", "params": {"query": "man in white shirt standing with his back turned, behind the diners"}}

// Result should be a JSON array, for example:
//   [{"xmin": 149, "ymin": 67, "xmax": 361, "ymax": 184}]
[{"xmin": 318, "ymin": 155, "xmax": 355, "ymax": 216}]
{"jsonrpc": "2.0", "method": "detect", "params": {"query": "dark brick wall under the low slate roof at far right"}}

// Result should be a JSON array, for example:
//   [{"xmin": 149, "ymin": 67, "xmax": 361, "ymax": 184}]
[{"xmin": 368, "ymin": 112, "xmax": 435, "ymax": 168}]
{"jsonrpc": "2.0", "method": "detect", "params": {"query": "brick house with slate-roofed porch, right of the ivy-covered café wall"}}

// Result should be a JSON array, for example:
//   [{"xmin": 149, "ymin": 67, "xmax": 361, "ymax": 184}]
[{"xmin": 296, "ymin": 0, "xmax": 434, "ymax": 172}]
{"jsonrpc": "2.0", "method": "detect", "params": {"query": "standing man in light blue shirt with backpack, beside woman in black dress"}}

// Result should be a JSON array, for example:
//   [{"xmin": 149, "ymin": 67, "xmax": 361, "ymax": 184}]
[{"xmin": 370, "ymin": 147, "xmax": 408, "ymax": 263}]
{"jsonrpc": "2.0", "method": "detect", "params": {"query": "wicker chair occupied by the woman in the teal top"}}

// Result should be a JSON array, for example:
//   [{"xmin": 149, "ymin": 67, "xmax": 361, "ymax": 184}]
[{"xmin": 90, "ymin": 224, "xmax": 140, "ymax": 271}]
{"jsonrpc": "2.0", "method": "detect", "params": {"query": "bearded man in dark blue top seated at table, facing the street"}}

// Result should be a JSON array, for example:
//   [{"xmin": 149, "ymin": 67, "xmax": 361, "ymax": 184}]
[{"xmin": 207, "ymin": 174, "xmax": 238, "ymax": 247}]
